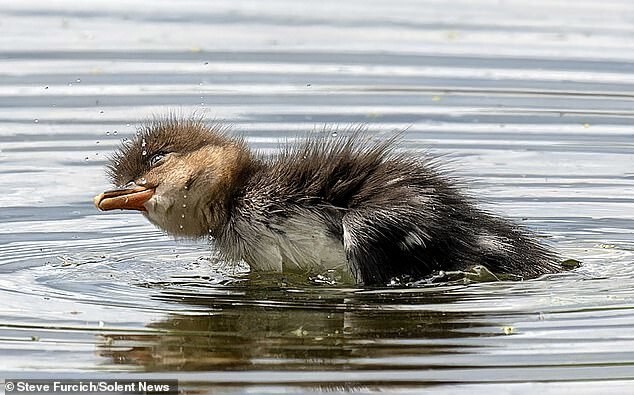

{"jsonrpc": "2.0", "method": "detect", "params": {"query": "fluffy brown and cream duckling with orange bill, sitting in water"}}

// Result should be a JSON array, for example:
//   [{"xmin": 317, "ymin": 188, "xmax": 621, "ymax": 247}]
[{"xmin": 94, "ymin": 118, "xmax": 559, "ymax": 285}]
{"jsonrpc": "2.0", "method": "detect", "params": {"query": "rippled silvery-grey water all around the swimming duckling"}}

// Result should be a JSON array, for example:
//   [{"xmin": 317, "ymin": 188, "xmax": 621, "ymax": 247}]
[{"xmin": 0, "ymin": 0, "xmax": 634, "ymax": 394}]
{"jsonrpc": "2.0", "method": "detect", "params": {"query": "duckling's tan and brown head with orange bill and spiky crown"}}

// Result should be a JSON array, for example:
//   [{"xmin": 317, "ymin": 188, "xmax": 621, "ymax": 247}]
[{"xmin": 94, "ymin": 118, "xmax": 251, "ymax": 238}]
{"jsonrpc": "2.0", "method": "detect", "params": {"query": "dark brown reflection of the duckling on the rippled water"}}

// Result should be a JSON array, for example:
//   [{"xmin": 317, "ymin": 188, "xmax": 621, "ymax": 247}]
[{"xmin": 99, "ymin": 285, "xmax": 470, "ymax": 370}]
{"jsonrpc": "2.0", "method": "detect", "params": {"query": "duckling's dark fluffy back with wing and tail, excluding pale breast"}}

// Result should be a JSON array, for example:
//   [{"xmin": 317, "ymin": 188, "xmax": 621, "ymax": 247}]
[{"xmin": 239, "ymin": 130, "xmax": 558, "ymax": 284}]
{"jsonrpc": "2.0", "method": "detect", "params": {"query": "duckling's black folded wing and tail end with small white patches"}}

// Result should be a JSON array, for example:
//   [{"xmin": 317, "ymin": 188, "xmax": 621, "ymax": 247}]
[{"xmin": 342, "ymin": 203, "xmax": 560, "ymax": 285}]
